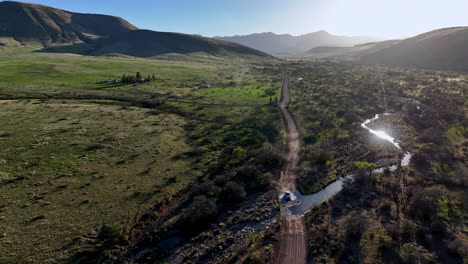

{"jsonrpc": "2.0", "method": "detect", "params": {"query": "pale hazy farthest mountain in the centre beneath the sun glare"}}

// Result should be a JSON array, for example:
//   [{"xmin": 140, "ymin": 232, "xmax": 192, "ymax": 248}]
[{"xmin": 215, "ymin": 30, "xmax": 380, "ymax": 55}]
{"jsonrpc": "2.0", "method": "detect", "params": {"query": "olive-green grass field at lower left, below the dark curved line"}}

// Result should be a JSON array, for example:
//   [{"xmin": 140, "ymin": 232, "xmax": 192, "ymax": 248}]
[{"xmin": 0, "ymin": 100, "xmax": 200, "ymax": 263}]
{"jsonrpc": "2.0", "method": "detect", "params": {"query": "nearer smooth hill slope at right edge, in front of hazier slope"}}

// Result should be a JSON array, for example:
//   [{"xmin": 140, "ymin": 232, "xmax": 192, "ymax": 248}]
[{"xmin": 361, "ymin": 27, "xmax": 468, "ymax": 71}]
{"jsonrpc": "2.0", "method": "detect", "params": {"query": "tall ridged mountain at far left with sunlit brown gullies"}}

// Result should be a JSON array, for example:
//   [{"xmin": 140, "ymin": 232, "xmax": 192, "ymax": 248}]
[{"xmin": 0, "ymin": 1, "xmax": 138, "ymax": 46}]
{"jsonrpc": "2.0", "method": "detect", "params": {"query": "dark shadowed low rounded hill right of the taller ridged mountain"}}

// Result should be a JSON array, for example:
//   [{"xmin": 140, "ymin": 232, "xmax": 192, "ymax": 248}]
[{"xmin": 44, "ymin": 30, "xmax": 273, "ymax": 59}]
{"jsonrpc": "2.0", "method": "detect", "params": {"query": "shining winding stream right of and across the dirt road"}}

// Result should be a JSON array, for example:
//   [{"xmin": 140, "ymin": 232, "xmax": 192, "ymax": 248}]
[{"xmin": 284, "ymin": 113, "xmax": 412, "ymax": 215}]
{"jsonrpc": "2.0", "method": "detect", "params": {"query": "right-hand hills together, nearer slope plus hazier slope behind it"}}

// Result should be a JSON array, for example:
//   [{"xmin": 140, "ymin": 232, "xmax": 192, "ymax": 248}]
[{"xmin": 298, "ymin": 27, "xmax": 468, "ymax": 71}]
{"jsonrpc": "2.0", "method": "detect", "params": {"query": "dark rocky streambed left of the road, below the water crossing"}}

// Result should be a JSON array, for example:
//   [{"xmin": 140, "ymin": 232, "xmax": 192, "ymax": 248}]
[{"xmin": 130, "ymin": 191, "xmax": 279, "ymax": 263}]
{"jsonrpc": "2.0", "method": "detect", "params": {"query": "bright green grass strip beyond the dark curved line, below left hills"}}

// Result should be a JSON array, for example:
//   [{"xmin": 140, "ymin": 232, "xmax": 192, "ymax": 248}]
[{"xmin": 0, "ymin": 48, "xmax": 279, "ymax": 102}]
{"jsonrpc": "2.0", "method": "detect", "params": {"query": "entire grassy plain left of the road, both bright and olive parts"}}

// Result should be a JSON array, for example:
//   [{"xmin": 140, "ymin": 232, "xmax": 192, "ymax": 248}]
[{"xmin": 0, "ymin": 48, "xmax": 279, "ymax": 263}]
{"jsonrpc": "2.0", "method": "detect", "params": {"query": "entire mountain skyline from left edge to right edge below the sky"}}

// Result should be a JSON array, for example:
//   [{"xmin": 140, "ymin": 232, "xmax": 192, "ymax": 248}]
[{"xmin": 0, "ymin": 1, "xmax": 468, "ymax": 71}]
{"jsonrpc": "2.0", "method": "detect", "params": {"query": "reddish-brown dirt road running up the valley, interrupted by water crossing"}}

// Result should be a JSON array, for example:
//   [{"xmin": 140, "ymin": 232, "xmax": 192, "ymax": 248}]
[{"xmin": 276, "ymin": 75, "xmax": 307, "ymax": 264}]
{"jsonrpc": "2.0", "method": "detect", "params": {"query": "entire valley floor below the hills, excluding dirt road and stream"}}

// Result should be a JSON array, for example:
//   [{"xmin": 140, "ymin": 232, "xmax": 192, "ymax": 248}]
[{"xmin": 0, "ymin": 50, "xmax": 468, "ymax": 263}]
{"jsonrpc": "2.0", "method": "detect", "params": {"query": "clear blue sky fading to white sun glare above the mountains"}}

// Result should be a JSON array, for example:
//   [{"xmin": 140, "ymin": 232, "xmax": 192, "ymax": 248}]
[{"xmin": 7, "ymin": 0, "xmax": 468, "ymax": 38}]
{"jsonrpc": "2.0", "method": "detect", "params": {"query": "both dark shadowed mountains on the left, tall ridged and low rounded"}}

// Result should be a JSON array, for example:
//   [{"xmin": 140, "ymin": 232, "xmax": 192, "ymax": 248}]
[{"xmin": 0, "ymin": 1, "xmax": 275, "ymax": 59}]
